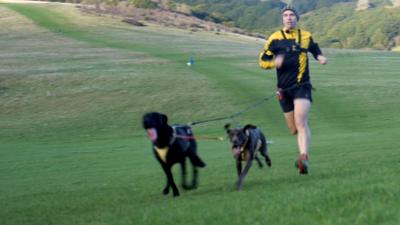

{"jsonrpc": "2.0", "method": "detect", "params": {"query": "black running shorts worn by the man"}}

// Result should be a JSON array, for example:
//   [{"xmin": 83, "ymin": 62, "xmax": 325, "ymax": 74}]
[{"xmin": 279, "ymin": 84, "xmax": 312, "ymax": 113}]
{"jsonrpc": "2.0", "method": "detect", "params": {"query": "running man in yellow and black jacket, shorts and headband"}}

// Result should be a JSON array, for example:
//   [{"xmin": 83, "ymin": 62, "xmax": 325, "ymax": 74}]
[{"xmin": 259, "ymin": 6, "xmax": 328, "ymax": 174}]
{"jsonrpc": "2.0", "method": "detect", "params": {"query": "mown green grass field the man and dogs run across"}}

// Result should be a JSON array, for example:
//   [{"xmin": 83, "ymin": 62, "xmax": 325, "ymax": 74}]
[{"xmin": 0, "ymin": 4, "xmax": 400, "ymax": 225}]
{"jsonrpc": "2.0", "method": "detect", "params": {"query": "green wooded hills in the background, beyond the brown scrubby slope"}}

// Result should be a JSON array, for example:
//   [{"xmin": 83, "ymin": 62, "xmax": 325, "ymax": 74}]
[{"xmin": 170, "ymin": 0, "xmax": 400, "ymax": 50}]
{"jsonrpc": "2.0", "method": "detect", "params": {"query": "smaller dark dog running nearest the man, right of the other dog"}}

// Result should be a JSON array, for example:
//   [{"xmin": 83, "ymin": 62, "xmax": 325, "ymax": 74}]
[{"xmin": 225, "ymin": 124, "xmax": 271, "ymax": 190}]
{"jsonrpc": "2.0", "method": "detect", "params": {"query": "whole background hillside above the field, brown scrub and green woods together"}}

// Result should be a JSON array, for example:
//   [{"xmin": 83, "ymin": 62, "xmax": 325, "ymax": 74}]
[{"xmin": 8, "ymin": 0, "xmax": 400, "ymax": 51}]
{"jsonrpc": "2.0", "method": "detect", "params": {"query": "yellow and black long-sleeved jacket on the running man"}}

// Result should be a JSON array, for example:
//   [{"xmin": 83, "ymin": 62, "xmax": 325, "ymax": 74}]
[{"xmin": 259, "ymin": 29, "xmax": 322, "ymax": 89}]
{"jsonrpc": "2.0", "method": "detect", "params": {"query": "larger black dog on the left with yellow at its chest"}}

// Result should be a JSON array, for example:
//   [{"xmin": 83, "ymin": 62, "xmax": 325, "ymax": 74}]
[{"xmin": 143, "ymin": 112, "xmax": 206, "ymax": 197}]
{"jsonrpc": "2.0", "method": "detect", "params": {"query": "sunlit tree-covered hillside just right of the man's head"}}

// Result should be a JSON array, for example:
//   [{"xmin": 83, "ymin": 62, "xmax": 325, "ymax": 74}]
[{"xmin": 301, "ymin": 4, "xmax": 400, "ymax": 50}]
